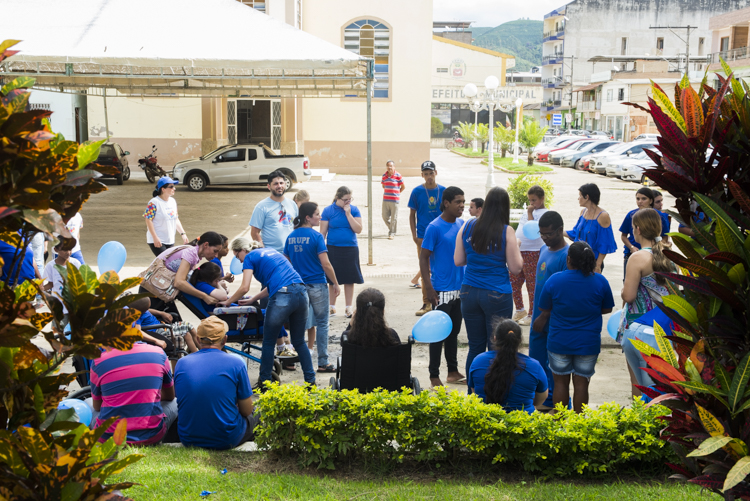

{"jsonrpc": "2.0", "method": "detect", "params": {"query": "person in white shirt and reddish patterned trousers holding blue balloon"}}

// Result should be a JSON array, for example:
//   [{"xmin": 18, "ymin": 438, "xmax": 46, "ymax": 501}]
[{"xmin": 510, "ymin": 185, "xmax": 547, "ymax": 325}]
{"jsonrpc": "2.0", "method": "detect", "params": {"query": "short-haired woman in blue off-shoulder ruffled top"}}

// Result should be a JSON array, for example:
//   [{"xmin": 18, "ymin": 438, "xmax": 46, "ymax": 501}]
[{"xmin": 565, "ymin": 183, "xmax": 617, "ymax": 273}]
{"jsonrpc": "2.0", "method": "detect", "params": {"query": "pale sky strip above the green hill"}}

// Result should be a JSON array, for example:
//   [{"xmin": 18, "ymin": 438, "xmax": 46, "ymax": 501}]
[{"xmin": 432, "ymin": 0, "xmax": 570, "ymax": 27}]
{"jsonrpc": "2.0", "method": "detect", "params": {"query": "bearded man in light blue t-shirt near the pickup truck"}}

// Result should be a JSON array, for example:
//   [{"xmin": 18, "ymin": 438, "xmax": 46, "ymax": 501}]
[{"xmin": 250, "ymin": 170, "xmax": 299, "ymax": 252}]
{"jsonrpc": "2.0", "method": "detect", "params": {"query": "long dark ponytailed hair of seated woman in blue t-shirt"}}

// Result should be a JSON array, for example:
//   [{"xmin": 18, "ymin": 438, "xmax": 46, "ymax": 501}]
[{"xmin": 484, "ymin": 318, "xmax": 523, "ymax": 404}]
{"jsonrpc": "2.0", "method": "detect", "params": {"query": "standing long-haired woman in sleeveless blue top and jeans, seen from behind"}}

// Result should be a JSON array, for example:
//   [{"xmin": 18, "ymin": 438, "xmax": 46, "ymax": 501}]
[{"xmin": 454, "ymin": 187, "xmax": 523, "ymax": 378}]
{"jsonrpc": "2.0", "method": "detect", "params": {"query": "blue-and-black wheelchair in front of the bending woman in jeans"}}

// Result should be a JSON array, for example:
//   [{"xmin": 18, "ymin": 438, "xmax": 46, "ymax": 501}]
[{"xmin": 177, "ymin": 293, "xmax": 284, "ymax": 382}]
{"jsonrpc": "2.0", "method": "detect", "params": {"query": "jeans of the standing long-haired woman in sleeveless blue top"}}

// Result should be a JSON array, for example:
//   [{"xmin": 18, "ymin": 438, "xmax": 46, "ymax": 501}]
[{"xmin": 461, "ymin": 285, "xmax": 513, "ymax": 374}]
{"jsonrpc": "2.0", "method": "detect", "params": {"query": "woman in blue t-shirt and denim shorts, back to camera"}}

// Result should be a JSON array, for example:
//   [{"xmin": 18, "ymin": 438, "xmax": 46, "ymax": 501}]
[{"xmin": 532, "ymin": 242, "xmax": 615, "ymax": 412}]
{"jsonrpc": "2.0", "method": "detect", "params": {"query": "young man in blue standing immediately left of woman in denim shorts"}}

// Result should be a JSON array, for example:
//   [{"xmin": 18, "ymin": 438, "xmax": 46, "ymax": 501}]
[{"xmin": 529, "ymin": 211, "xmax": 568, "ymax": 407}]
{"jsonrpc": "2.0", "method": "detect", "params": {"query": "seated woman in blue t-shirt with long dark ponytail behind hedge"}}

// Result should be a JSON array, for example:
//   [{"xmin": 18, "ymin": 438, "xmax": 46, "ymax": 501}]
[{"xmin": 468, "ymin": 319, "xmax": 547, "ymax": 414}]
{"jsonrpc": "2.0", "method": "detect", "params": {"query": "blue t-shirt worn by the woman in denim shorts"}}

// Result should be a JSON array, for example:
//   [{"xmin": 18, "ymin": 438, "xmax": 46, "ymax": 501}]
[{"xmin": 539, "ymin": 270, "xmax": 615, "ymax": 355}]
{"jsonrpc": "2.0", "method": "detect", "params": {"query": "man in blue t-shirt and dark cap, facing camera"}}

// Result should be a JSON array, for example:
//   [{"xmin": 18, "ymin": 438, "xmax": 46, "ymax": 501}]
[{"xmin": 409, "ymin": 160, "xmax": 445, "ymax": 317}]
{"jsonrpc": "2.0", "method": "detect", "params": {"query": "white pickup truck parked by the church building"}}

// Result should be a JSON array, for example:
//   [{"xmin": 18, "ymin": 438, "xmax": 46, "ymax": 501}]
[{"xmin": 172, "ymin": 143, "xmax": 311, "ymax": 191}]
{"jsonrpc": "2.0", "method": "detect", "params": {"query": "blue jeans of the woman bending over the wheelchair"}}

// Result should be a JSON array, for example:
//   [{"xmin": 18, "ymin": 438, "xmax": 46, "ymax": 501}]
[{"xmin": 260, "ymin": 284, "xmax": 315, "ymax": 384}]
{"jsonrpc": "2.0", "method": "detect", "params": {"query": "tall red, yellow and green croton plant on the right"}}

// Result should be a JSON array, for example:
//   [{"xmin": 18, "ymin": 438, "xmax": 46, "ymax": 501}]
[{"xmin": 629, "ymin": 61, "xmax": 750, "ymax": 499}]
